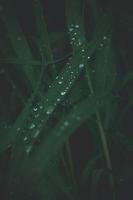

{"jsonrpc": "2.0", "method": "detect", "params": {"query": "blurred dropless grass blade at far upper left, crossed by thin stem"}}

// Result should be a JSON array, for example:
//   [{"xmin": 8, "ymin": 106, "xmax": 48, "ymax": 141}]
[{"xmin": 2, "ymin": 3, "xmax": 36, "ymax": 87}]
